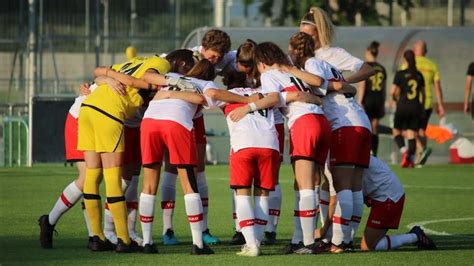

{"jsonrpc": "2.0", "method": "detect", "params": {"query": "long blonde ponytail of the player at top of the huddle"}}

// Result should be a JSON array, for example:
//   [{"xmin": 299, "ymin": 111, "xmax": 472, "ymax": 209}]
[{"xmin": 301, "ymin": 7, "xmax": 335, "ymax": 47}]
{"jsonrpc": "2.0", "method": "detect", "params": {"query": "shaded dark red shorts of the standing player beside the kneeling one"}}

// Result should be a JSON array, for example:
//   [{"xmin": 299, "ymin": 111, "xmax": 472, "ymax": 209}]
[{"xmin": 330, "ymin": 127, "xmax": 372, "ymax": 168}]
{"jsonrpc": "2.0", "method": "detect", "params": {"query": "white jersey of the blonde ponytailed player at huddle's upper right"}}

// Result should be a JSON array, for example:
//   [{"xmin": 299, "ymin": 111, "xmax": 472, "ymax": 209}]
[{"xmin": 314, "ymin": 47, "xmax": 364, "ymax": 72}]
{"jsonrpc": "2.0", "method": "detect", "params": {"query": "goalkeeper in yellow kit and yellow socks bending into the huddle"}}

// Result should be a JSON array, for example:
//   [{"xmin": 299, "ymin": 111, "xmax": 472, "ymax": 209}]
[{"xmin": 78, "ymin": 56, "xmax": 170, "ymax": 252}]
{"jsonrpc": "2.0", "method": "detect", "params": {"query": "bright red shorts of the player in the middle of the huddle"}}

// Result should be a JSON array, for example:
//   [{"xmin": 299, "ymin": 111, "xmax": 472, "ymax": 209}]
[{"xmin": 229, "ymin": 148, "xmax": 280, "ymax": 190}]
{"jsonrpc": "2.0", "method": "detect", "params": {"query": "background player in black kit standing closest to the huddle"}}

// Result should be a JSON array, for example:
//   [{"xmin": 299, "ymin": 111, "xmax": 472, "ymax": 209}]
[{"xmin": 358, "ymin": 41, "xmax": 387, "ymax": 156}]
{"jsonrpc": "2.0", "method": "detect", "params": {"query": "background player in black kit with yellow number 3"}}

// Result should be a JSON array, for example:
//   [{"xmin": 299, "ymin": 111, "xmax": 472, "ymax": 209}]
[{"xmin": 391, "ymin": 50, "xmax": 426, "ymax": 168}]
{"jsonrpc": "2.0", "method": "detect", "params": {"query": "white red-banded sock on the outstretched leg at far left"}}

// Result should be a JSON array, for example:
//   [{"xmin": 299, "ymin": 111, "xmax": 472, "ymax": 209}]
[{"xmin": 49, "ymin": 181, "xmax": 82, "ymax": 225}]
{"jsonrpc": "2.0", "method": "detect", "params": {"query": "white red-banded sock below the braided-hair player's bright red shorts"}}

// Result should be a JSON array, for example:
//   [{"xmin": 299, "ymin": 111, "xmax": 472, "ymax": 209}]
[{"xmin": 299, "ymin": 189, "xmax": 316, "ymax": 246}]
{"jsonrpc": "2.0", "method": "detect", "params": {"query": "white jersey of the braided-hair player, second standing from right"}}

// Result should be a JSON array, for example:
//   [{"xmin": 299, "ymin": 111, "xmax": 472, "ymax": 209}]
[{"xmin": 260, "ymin": 69, "xmax": 323, "ymax": 128}]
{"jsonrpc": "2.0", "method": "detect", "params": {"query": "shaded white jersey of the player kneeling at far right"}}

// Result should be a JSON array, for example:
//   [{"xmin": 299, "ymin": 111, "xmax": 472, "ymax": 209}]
[{"xmin": 362, "ymin": 156, "xmax": 405, "ymax": 202}]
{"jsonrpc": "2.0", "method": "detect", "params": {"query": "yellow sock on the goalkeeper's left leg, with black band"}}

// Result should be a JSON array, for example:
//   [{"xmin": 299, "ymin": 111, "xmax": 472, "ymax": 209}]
[{"xmin": 84, "ymin": 168, "xmax": 105, "ymax": 240}]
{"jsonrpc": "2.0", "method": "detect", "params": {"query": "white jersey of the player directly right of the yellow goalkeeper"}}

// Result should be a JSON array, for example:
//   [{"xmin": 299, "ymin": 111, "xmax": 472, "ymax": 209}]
[{"xmin": 143, "ymin": 73, "xmax": 216, "ymax": 131}]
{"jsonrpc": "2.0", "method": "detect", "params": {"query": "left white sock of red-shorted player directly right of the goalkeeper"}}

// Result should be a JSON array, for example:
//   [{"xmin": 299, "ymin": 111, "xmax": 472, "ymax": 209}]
[{"xmin": 139, "ymin": 193, "xmax": 156, "ymax": 246}]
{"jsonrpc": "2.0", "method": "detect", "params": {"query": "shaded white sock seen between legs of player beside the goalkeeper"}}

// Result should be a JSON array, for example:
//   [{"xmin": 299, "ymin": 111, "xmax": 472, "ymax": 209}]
[{"xmin": 160, "ymin": 171, "xmax": 178, "ymax": 235}]
